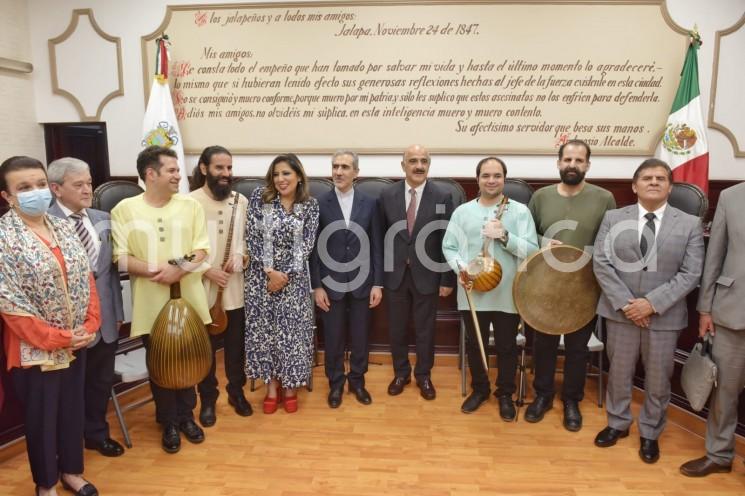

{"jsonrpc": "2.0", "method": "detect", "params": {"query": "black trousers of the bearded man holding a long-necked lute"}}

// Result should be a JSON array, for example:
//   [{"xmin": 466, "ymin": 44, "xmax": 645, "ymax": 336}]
[{"xmin": 197, "ymin": 308, "xmax": 246, "ymax": 405}]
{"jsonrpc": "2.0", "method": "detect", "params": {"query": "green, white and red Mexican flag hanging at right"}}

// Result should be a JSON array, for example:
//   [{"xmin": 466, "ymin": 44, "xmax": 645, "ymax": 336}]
[{"xmin": 660, "ymin": 33, "xmax": 709, "ymax": 194}]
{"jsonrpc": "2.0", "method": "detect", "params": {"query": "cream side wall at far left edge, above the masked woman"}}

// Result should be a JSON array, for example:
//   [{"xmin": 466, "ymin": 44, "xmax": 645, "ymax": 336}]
[{"xmin": 0, "ymin": 0, "xmax": 45, "ymax": 161}]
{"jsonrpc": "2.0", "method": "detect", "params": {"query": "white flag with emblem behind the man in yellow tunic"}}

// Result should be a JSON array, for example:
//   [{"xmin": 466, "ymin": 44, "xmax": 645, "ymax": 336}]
[{"xmin": 140, "ymin": 35, "xmax": 189, "ymax": 193}]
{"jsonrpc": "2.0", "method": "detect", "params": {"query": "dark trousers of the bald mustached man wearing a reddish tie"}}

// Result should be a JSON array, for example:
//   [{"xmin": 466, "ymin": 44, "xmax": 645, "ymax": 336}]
[{"xmin": 386, "ymin": 267, "xmax": 438, "ymax": 380}]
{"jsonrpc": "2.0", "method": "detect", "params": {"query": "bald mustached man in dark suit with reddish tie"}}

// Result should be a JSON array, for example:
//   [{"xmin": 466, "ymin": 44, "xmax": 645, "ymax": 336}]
[{"xmin": 379, "ymin": 145, "xmax": 455, "ymax": 400}]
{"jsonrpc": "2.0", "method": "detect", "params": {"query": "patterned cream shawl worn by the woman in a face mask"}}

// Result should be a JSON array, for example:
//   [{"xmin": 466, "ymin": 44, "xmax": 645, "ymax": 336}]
[{"xmin": 0, "ymin": 210, "xmax": 91, "ymax": 371}]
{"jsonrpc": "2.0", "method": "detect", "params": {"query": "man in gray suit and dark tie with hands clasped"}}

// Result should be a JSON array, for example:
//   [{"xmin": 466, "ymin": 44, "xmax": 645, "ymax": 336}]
[{"xmin": 593, "ymin": 159, "xmax": 704, "ymax": 463}]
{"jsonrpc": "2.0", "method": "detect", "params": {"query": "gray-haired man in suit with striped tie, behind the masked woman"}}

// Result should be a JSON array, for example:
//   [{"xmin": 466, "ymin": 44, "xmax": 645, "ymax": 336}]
[{"xmin": 47, "ymin": 157, "xmax": 124, "ymax": 456}]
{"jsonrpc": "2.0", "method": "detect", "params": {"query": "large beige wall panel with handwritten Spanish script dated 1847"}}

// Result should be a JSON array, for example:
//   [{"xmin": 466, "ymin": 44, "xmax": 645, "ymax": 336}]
[{"xmin": 142, "ymin": 1, "xmax": 686, "ymax": 155}]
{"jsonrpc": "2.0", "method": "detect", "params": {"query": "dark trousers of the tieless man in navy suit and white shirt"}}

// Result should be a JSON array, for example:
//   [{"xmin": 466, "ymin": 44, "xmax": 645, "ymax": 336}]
[{"xmin": 322, "ymin": 293, "xmax": 370, "ymax": 389}]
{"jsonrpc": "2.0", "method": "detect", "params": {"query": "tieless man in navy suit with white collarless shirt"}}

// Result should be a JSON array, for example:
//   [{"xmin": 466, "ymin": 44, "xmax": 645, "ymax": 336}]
[{"xmin": 310, "ymin": 150, "xmax": 383, "ymax": 408}]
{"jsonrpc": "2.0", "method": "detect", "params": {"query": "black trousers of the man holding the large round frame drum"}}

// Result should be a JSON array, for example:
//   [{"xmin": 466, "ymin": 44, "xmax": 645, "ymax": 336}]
[{"xmin": 533, "ymin": 318, "xmax": 597, "ymax": 401}]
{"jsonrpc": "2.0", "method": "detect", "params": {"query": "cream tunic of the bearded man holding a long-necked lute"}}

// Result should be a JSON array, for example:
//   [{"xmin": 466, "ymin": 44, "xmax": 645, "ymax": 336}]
[{"xmin": 189, "ymin": 188, "xmax": 248, "ymax": 310}]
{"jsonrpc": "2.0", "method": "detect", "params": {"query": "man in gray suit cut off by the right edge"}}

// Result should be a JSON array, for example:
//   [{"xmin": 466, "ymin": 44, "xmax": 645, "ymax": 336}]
[{"xmin": 680, "ymin": 183, "xmax": 745, "ymax": 477}]
